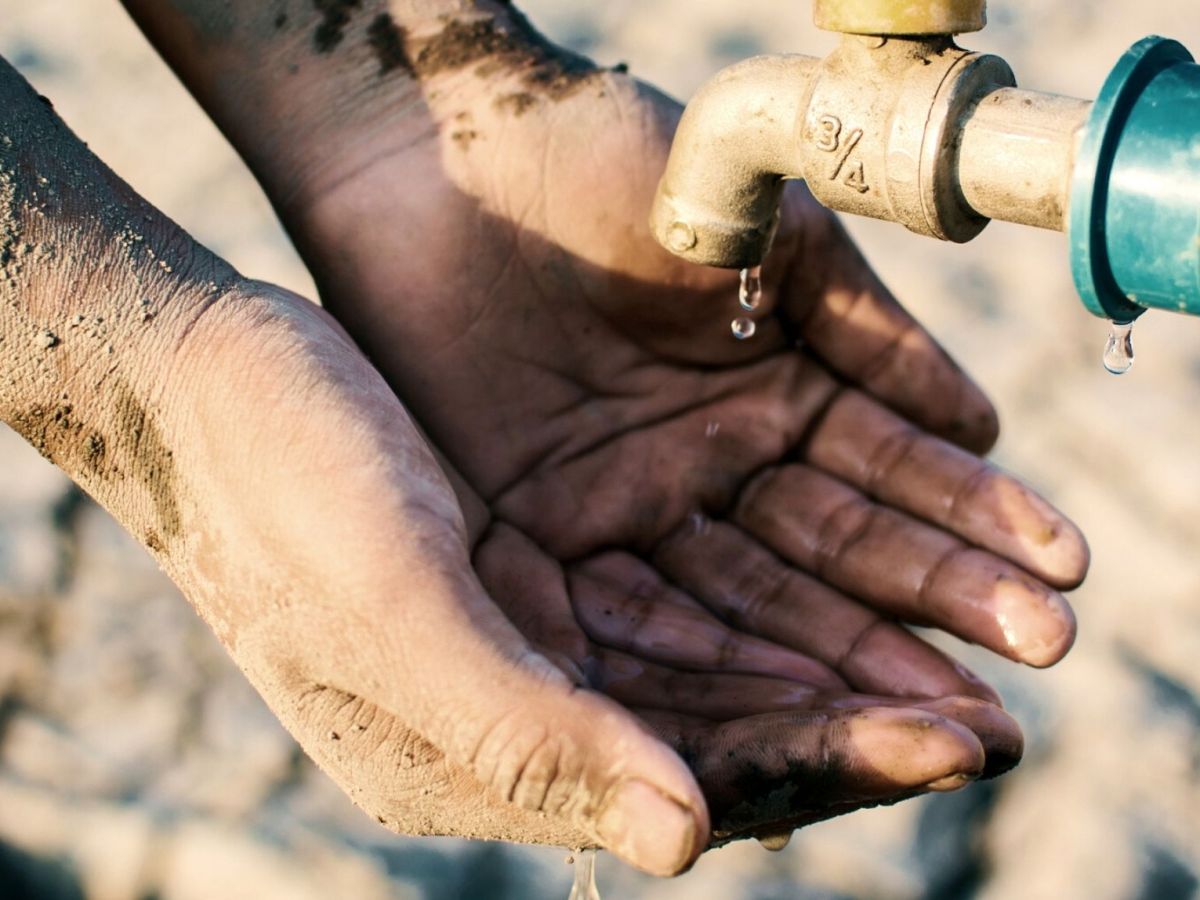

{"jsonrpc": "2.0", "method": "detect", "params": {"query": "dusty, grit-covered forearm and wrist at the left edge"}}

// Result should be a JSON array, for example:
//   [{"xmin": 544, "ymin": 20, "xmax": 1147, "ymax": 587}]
[{"xmin": 0, "ymin": 54, "xmax": 249, "ymax": 546}]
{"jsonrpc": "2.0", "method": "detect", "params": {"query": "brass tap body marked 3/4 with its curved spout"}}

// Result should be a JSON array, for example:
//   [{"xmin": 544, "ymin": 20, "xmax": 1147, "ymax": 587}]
[{"xmin": 650, "ymin": 35, "xmax": 1017, "ymax": 269}]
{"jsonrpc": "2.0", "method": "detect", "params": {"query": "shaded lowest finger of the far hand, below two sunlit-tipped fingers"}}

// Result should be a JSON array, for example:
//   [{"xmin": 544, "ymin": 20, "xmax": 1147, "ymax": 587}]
[{"xmin": 654, "ymin": 522, "xmax": 1000, "ymax": 704}]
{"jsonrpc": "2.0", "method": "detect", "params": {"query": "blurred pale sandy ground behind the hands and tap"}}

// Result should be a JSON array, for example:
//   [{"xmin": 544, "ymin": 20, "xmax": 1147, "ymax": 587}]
[{"xmin": 0, "ymin": 0, "xmax": 1200, "ymax": 900}]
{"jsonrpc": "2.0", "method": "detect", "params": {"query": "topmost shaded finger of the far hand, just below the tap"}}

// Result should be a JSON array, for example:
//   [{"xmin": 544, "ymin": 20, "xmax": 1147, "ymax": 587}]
[{"xmin": 781, "ymin": 205, "xmax": 1000, "ymax": 452}]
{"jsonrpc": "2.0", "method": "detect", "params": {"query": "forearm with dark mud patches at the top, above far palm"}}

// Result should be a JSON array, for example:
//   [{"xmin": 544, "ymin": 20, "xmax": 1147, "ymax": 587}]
[{"xmin": 122, "ymin": 0, "xmax": 595, "ymax": 205}]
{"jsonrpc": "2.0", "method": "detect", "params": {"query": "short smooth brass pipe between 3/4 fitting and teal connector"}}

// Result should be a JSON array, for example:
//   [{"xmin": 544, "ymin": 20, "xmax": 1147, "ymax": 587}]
[{"xmin": 958, "ymin": 88, "xmax": 1092, "ymax": 232}]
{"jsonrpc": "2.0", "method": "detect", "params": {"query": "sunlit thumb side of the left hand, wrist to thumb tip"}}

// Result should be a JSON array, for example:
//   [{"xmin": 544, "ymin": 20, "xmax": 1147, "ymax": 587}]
[{"xmin": 158, "ymin": 284, "xmax": 724, "ymax": 875}]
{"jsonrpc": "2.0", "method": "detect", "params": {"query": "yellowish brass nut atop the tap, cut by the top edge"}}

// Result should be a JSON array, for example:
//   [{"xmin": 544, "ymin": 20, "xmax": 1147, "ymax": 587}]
[{"xmin": 814, "ymin": 0, "xmax": 988, "ymax": 36}]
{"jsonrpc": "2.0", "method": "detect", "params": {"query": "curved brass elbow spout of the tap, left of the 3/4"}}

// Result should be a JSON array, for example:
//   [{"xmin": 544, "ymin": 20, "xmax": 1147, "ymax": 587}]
[{"xmin": 650, "ymin": 55, "xmax": 820, "ymax": 269}]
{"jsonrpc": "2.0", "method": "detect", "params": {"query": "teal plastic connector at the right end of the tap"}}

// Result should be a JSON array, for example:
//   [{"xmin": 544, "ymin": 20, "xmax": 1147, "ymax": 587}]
[{"xmin": 1069, "ymin": 37, "xmax": 1200, "ymax": 323}]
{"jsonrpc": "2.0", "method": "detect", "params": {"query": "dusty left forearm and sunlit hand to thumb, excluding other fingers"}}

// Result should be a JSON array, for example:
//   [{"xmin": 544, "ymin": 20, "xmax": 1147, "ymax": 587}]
[{"xmin": 0, "ymin": 51, "xmax": 734, "ymax": 874}]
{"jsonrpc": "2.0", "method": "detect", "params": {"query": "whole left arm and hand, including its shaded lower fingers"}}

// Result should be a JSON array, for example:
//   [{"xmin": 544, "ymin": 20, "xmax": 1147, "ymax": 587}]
[{"xmin": 0, "ymin": 31, "xmax": 1065, "ymax": 874}]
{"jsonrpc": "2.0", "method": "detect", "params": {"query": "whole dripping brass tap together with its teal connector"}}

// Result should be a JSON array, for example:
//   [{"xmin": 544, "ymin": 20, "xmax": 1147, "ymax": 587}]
[{"xmin": 650, "ymin": 0, "xmax": 1200, "ymax": 323}]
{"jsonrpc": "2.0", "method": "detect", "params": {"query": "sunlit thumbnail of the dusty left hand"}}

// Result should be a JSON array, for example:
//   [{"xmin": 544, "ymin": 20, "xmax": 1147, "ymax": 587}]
[{"xmin": 596, "ymin": 780, "xmax": 696, "ymax": 876}]
